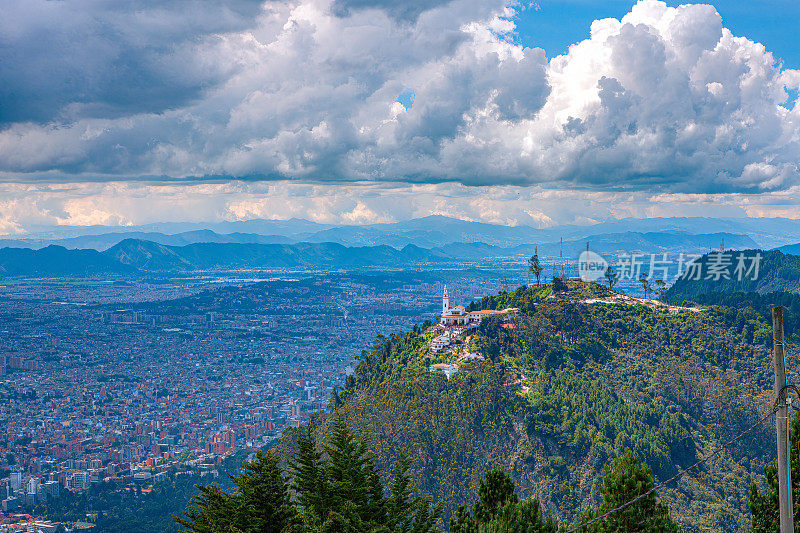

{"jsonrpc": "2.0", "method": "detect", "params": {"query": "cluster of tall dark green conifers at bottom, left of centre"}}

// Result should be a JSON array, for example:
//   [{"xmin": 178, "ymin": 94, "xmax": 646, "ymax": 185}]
[{"xmin": 178, "ymin": 417, "xmax": 441, "ymax": 533}]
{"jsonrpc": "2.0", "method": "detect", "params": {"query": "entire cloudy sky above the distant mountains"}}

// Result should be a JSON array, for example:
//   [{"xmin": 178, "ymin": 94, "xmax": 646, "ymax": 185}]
[{"xmin": 0, "ymin": 0, "xmax": 800, "ymax": 234}]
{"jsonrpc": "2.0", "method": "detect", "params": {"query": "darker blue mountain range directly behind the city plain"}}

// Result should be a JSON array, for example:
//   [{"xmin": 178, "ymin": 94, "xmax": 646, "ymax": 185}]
[{"xmin": 0, "ymin": 230, "xmax": 755, "ymax": 277}]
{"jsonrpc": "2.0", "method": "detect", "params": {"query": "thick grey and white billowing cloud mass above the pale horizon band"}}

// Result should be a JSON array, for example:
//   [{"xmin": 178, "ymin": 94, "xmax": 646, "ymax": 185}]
[{"xmin": 0, "ymin": 0, "xmax": 800, "ymax": 193}]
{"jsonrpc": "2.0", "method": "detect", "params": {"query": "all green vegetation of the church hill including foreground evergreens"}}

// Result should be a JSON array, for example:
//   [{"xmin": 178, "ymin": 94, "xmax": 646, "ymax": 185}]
[{"xmin": 65, "ymin": 274, "xmax": 800, "ymax": 533}]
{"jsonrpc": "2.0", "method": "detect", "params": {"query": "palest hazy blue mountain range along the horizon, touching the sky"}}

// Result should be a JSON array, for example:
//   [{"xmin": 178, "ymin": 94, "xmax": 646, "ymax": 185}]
[{"xmin": 0, "ymin": 215, "xmax": 800, "ymax": 251}]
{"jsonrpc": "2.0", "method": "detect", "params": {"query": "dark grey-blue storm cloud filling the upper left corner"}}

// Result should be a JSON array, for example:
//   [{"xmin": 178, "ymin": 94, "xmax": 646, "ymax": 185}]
[{"xmin": 0, "ymin": 0, "xmax": 261, "ymax": 126}]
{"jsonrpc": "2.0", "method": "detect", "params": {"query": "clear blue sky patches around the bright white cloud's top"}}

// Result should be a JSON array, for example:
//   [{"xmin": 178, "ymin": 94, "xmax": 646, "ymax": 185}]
[{"xmin": 516, "ymin": 0, "xmax": 800, "ymax": 68}]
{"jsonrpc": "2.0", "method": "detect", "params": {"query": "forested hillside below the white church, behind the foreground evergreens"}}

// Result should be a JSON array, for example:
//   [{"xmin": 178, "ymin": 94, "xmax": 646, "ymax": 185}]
[{"xmin": 278, "ymin": 283, "xmax": 788, "ymax": 531}]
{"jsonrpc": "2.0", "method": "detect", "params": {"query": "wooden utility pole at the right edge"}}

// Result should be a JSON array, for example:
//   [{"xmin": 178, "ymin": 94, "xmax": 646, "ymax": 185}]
[{"xmin": 772, "ymin": 306, "xmax": 794, "ymax": 533}]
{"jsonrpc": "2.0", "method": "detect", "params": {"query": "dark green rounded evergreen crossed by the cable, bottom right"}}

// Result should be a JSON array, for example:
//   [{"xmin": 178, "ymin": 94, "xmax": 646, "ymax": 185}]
[{"xmin": 580, "ymin": 449, "xmax": 680, "ymax": 533}]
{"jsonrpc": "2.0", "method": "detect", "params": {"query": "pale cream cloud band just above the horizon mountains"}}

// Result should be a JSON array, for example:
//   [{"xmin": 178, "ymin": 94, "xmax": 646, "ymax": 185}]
[{"xmin": 6, "ymin": 181, "xmax": 800, "ymax": 235}]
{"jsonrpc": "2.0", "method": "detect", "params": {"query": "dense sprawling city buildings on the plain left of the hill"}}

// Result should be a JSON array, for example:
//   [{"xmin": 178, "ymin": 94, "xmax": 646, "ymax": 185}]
[{"xmin": 0, "ymin": 273, "xmax": 516, "ymax": 524}]
